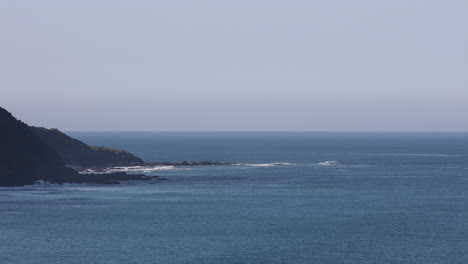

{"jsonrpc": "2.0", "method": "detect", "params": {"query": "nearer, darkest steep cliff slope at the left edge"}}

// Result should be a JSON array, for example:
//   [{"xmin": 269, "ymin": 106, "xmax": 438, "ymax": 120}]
[{"xmin": 0, "ymin": 107, "xmax": 78, "ymax": 186}]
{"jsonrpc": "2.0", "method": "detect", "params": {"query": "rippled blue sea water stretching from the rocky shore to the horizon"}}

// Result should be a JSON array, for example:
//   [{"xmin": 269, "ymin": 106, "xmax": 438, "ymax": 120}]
[{"xmin": 0, "ymin": 132, "xmax": 468, "ymax": 264}]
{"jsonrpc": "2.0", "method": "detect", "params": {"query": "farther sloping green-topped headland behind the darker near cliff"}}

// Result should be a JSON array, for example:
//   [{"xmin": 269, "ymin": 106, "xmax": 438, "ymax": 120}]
[{"xmin": 29, "ymin": 126, "xmax": 144, "ymax": 167}]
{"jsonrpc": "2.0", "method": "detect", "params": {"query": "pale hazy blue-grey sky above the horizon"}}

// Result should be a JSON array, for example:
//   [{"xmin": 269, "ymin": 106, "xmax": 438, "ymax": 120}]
[{"xmin": 0, "ymin": 0, "xmax": 468, "ymax": 131}]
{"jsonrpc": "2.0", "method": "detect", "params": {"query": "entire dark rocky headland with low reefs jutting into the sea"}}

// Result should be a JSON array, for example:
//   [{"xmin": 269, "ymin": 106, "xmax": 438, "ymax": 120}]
[{"xmin": 0, "ymin": 107, "xmax": 235, "ymax": 187}]
